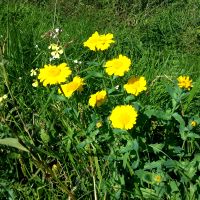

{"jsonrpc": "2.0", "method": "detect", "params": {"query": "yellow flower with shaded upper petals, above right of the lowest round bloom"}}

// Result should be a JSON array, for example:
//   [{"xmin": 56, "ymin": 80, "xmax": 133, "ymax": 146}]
[{"xmin": 124, "ymin": 76, "xmax": 147, "ymax": 96}]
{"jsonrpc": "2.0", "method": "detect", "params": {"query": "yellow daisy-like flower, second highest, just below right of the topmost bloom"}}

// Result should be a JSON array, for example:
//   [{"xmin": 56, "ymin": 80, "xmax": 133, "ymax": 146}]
[{"xmin": 105, "ymin": 54, "xmax": 131, "ymax": 76}]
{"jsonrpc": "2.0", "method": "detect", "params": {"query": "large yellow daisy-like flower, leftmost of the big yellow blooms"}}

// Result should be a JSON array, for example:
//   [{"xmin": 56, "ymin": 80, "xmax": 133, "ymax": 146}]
[{"xmin": 38, "ymin": 63, "xmax": 72, "ymax": 86}]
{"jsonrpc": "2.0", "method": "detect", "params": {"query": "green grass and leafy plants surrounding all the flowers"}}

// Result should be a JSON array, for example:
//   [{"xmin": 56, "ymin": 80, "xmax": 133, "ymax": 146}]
[{"xmin": 0, "ymin": 0, "xmax": 200, "ymax": 200}]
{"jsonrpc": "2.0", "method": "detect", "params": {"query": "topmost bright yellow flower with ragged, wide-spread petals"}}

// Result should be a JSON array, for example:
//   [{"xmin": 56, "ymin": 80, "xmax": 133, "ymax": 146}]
[{"xmin": 83, "ymin": 31, "xmax": 115, "ymax": 51}]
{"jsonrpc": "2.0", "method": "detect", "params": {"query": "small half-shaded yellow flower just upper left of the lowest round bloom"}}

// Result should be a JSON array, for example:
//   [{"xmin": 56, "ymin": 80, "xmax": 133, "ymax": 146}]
[{"xmin": 89, "ymin": 90, "xmax": 107, "ymax": 108}]
